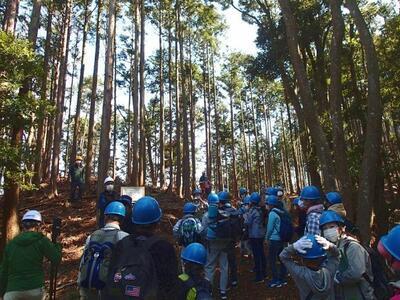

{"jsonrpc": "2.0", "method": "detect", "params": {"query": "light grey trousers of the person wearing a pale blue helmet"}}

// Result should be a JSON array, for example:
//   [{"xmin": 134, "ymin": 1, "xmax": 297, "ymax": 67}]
[{"xmin": 204, "ymin": 241, "xmax": 228, "ymax": 292}]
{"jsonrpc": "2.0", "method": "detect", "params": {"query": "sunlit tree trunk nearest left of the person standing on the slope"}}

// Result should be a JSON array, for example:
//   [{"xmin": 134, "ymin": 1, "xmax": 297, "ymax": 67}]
[{"xmin": 51, "ymin": 0, "xmax": 72, "ymax": 196}]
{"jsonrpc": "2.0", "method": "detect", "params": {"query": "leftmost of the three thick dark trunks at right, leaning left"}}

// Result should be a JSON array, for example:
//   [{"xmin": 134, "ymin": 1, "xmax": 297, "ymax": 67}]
[{"xmin": 279, "ymin": 0, "xmax": 336, "ymax": 190}]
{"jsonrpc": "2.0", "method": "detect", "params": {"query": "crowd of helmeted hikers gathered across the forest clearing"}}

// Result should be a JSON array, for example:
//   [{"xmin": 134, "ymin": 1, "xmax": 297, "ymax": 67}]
[{"xmin": 0, "ymin": 169, "xmax": 400, "ymax": 300}]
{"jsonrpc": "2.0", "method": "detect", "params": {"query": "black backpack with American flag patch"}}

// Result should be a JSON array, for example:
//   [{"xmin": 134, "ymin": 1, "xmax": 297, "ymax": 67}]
[{"xmin": 107, "ymin": 236, "xmax": 160, "ymax": 300}]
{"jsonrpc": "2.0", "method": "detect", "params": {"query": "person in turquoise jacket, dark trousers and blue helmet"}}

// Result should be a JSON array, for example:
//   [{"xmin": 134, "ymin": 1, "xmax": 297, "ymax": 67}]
[{"xmin": 265, "ymin": 195, "xmax": 290, "ymax": 288}]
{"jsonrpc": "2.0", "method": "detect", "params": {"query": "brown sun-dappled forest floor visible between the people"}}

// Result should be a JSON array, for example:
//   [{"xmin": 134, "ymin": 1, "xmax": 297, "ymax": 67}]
[{"xmin": 14, "ymin": 180, "xmax": 298, "ymax": 300}]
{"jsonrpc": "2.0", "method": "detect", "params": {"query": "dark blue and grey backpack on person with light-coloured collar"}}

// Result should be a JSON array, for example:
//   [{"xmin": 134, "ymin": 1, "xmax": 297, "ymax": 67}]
[{"xmin": 79, "ymin": 229, "xmax": 119, "ymax": 290}]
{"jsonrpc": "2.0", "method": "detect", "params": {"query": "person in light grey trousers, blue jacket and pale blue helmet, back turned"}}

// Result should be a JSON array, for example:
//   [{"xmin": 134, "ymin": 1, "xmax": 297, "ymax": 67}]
[{"xmin": 201, "ymin": 193, "xmax": 231, "ymax": 300}]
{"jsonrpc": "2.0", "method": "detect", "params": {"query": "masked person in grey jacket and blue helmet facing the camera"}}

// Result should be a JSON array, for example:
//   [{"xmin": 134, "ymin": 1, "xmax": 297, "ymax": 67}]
[{"xmin": 319, "ymin": 210, "xmax": 374, "ymax": 299}]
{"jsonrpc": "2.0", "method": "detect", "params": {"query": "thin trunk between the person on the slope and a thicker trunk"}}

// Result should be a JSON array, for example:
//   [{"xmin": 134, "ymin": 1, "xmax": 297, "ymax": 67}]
[{"xmin": 85, "ymin": 0, "xmax": 103, "ymax": 184}]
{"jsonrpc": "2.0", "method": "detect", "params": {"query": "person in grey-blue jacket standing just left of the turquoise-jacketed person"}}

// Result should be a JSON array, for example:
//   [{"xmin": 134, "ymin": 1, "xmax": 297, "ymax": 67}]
[{"xmin": 244, "ymin": 192, "xmax": 266, "ymax": 283}]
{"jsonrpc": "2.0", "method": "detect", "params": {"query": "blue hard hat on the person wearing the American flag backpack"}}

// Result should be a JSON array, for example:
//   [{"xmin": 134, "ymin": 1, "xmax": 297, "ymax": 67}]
[{"xmin": 132, "ymin": 196, "xmax": 162, "ymax": 225}]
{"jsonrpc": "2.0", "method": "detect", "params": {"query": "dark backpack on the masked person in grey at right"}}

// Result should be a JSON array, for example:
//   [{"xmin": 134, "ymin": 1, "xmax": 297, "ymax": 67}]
[{"xmin": 344, "ymin": 242, "xmax": 391, "ymax": 299}]
